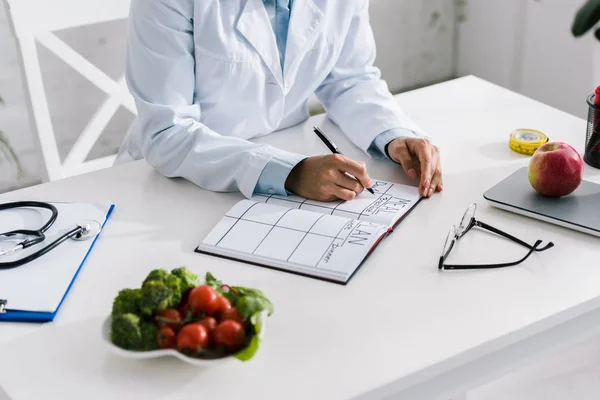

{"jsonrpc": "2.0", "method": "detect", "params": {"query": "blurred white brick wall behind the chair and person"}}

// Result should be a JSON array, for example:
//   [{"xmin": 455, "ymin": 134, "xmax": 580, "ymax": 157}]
[{"xmin": 0, "ymin": 0, "xmax": 454, "ymax": 192}]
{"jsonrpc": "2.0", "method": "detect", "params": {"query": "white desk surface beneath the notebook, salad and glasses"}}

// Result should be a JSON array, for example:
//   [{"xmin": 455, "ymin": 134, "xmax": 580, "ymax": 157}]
[{"xmin": 0, "ymin": 77, "xmax": 600, "ymax": 399}]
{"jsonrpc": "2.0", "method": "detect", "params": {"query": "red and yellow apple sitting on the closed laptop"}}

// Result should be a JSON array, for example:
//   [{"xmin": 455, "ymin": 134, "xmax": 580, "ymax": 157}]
[{"xmin": 528, "ymin": 142, "xmax": 583, "ymax": 197}]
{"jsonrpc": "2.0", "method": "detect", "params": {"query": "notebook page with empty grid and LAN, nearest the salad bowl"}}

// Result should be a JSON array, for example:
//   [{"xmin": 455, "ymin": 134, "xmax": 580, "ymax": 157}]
[{"xmin": 197, "ymin": 200, "xmax": 387, "ymax": 281}]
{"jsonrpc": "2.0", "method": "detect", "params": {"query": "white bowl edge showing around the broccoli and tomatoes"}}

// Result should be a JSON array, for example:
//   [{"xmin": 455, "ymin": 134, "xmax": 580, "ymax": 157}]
[{"xmin": 102, "ymin": 313, "xmax": 267, "ymax": 367}]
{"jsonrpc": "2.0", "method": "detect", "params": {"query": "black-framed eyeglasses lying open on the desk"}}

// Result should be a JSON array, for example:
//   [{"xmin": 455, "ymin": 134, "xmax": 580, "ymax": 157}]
[{"xmin": 438, "ymin": 203, "xmax": 554, "ymax": 270}]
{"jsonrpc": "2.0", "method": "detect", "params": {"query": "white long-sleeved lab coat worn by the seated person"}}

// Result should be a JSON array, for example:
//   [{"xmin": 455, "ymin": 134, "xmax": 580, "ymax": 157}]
[{"xmin": 117, "ymin": 0, "xmax": 423, "ymax": 197}]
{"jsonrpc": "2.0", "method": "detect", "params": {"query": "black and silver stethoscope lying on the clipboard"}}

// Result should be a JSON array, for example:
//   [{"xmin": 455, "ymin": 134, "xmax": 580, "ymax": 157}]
[{"xmin": 0, "ymin": 201, "xmax": 101, "ymax": 270}]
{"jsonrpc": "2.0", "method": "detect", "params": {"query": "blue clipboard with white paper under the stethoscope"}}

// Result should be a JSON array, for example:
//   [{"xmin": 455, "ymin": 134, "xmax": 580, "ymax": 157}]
[{"xmin": 0, "ymin": 203, "xmax": 115, "ymax": 323}]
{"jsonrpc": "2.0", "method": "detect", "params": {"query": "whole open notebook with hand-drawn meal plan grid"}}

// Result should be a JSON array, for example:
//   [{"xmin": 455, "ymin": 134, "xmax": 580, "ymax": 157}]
[{"xmin": 196, "ymin": 181, "xmax": 421, "ymax": 284}]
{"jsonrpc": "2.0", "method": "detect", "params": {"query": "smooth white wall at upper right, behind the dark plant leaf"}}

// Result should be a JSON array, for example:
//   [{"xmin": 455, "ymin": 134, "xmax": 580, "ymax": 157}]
[{"xmin": 457, "ymin": 0, "xmax": 600, "ymax": 118}]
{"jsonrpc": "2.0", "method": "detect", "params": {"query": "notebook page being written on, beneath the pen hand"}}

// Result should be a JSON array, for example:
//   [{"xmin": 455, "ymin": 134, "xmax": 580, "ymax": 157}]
[{"xmin": 252, "ymin": 180, "xmax": 421, "ymax": 227}]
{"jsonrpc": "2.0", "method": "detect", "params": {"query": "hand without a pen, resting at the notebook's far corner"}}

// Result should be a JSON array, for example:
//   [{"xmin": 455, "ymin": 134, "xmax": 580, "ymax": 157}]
[{"xmin": 387, "ymin": 138, "xmax": 443, "ymax": 197}]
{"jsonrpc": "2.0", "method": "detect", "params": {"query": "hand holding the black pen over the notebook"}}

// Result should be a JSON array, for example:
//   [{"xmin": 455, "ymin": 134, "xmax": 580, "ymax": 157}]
[{"xmin": 285, "ymin": 154, "xmax": 371, "ymax": 201}]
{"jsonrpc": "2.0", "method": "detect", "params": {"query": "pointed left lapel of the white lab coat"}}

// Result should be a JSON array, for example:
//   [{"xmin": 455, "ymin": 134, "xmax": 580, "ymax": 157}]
[{"xmin": 236, "ymin": 0, "xmax": 283, "ymax": 87}]
